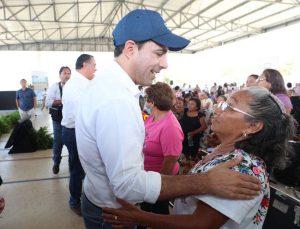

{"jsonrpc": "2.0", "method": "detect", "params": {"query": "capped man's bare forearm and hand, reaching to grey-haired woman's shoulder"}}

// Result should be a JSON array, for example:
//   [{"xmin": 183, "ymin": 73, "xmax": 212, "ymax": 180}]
[{"xmin": 158, "ymin": 158, "xmax": 261, "ymax": 200}]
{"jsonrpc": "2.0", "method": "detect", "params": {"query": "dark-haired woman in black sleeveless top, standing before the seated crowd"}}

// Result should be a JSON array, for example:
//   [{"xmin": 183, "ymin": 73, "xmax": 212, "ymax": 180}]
[{"xmin": 180, "ymin": 97, "xmax": 207, "ymax": 159}]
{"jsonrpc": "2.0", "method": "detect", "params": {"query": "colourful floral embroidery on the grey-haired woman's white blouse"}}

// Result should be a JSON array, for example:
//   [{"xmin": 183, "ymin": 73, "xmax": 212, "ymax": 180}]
[{"xmin": 190, "ymin": 149, "xmax": 270, "ymax": 225}]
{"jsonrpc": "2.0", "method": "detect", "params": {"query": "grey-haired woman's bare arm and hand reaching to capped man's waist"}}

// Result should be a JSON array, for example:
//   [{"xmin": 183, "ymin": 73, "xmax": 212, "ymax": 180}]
[{"xmin": 103, "ymin": 199, "xmax": 228, "ymax": 229}]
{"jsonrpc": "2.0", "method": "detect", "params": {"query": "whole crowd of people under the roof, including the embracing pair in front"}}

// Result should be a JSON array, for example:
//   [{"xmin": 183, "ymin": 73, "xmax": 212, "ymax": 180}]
[{"xmin": 8, "ymin": 10, "xmax": 299, "ymax": 229}]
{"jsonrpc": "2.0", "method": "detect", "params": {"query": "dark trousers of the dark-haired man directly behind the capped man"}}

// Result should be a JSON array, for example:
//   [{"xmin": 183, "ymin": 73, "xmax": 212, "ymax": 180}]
[{"xmin": 62, "ymin": 127, "xmax": 85, "ymax": 207}]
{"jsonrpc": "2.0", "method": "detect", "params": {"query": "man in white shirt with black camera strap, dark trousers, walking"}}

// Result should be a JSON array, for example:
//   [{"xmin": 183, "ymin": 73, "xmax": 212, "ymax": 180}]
[{"xmin": 45, "ymin": 66, "xmax": 71, "ymax": 174}]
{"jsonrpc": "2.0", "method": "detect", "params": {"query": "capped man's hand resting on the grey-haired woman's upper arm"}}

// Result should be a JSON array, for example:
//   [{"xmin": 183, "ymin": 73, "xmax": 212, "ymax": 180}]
[{"xmin": 205, "ymin": 157, "xmax": 261, "ymax": 200}]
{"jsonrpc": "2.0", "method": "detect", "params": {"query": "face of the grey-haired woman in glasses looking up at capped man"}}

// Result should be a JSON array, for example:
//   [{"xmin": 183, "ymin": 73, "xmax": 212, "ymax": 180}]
[{"xmin": 211, "ymin": 91, "xmax": 249, "ymax": 139}]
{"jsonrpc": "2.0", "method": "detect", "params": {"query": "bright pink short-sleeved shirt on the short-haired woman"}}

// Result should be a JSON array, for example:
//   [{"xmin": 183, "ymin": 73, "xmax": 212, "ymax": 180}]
[{"xmin": 143, "ymin": 111, "xmax": 183, "ymax": 175}]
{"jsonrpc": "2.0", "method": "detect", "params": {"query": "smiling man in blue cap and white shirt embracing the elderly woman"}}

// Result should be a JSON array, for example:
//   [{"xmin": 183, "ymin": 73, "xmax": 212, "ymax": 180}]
[{"xmin": 75, "ymin": 9, "xmax": 260, "ymax": 228}]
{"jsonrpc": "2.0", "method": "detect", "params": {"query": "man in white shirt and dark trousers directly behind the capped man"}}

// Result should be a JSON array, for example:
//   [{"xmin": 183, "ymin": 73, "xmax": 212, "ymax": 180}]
[{"xmin": 61, "ymin": 54, "xmax": 96, "ymax": 215}]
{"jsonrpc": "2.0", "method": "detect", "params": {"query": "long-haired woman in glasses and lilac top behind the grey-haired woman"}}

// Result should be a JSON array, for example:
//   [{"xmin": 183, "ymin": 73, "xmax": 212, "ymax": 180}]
[{"xmin": 258, "ymin": 69, "xmax": 293, "ymax": 114}]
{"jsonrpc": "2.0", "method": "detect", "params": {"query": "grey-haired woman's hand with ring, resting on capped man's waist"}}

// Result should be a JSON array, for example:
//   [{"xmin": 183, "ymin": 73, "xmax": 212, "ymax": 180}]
[{"xmin": 103, "ymin": 198, "xmax": 143, "ymax": 228}]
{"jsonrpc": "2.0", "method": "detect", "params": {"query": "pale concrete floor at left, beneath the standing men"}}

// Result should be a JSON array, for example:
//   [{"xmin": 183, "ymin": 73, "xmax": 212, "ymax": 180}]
[{"xmin": 0, "ymin": 111, "xmax": 85, "ymax": 229}]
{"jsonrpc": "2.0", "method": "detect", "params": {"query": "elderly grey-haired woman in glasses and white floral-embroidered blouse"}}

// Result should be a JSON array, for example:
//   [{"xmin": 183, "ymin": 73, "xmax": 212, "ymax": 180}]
[{"xmin": 105, "ymin": 87, "xmax": 295, "ymax": 229}]
